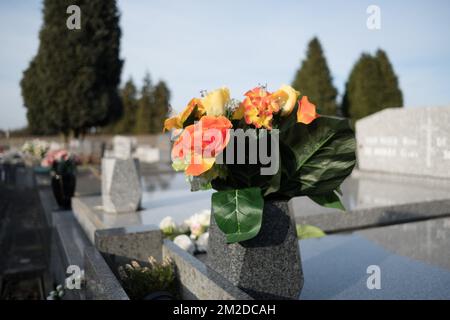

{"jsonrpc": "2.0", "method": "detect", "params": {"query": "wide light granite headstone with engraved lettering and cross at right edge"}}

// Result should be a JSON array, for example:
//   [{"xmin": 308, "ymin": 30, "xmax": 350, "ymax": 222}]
[{"xmin": 356, "ymin": 107, "xmax": 450, "ymax": 178}]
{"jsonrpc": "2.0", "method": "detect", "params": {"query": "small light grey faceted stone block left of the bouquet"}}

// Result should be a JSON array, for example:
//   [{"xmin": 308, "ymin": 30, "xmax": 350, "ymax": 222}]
[{"xmin": 102, "ymin": 158, "xmax": 142, "ymax": 213}]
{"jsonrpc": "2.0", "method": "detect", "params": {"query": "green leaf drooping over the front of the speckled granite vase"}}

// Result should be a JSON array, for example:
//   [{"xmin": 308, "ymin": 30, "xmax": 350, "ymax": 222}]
[{"xmin": 212, "ymin": 188, "xmax": 264, "ymax": 243}]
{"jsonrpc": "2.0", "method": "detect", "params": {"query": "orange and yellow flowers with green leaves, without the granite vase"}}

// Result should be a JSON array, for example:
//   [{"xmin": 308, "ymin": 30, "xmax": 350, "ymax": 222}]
[{"xmin": 164, "ymin": 85, "xmax": 355, "ymax": 243}]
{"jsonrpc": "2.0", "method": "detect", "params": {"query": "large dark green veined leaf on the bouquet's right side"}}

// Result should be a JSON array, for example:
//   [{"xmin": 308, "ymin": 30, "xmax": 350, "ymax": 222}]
[{"xmin": 278, "ymin": 116, "xmax": 356, "ymax": 198}]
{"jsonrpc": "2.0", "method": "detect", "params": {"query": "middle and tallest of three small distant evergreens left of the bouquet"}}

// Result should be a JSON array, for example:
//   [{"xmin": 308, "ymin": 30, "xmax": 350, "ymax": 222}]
[{"xmin": 135, "ymin": 73, "xmax": 154, "ymax": 134}]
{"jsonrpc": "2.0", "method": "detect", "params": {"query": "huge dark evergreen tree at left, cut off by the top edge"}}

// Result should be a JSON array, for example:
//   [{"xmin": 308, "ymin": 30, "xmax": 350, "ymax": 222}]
[{"xmin": 23, "ymin": 0, "xmax": 123, "ymax": 137}]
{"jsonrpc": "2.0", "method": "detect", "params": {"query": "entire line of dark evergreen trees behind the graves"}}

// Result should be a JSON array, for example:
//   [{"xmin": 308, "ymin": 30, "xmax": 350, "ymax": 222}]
[{"xmin": 20, "ymin": 0, "xmax": 403, "ymax": 138}]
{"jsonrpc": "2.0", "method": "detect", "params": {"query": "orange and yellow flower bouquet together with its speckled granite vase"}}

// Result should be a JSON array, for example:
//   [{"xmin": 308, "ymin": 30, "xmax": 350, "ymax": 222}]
[{"xmin": 164, "ymin": 85, "xmax": 356, "ymax": 299}]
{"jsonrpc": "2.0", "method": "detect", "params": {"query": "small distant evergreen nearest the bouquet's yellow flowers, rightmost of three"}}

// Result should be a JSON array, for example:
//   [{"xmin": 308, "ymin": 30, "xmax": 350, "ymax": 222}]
[{"xmin": 151, "ymin": 81, "xmax": 171, "ymax": 133}]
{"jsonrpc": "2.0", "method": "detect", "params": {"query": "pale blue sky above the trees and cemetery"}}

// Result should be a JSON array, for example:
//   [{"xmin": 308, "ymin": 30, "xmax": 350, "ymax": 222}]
[{"xmin": 0, "ymin": 0, "xmax": 450, "ymax": 129}]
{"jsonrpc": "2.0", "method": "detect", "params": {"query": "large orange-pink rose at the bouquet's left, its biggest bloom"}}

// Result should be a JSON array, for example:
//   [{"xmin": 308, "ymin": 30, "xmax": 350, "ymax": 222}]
[{"xmin": 172, "ymin": 116, "xmax": 232, "ymax": 176}]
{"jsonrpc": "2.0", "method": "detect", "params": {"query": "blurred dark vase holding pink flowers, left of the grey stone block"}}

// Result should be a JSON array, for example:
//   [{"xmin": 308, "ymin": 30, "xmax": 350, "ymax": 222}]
[{"xmin": 41, "ymin": 150, "xmax": 80, "ymax": 209}]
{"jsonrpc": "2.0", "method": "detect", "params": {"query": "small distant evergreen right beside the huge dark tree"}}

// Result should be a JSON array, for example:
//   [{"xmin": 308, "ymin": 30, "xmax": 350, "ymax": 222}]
[{"xmin": 114, "ymin": 78, "xmax": 138, "ymax": 134}]
